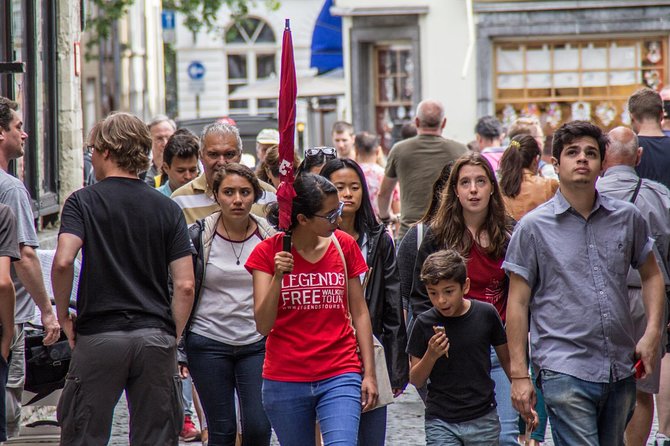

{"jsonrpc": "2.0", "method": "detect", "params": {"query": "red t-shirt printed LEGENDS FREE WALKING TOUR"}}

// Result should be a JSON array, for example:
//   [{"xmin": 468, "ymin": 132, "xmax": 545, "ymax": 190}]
[{"xmin": 245, "ymin": 230, "xmax": 367, "ymax": 382}]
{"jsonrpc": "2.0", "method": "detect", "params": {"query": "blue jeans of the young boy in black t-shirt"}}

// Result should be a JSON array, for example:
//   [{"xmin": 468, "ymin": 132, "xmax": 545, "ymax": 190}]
[{"xmin": 426, "ymin": 409, "xmax": 502, "ymax": 446}]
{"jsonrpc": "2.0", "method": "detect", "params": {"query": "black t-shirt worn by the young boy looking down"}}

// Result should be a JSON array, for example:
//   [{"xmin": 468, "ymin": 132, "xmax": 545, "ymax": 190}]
[{"xmin": 407, "ymin": 300, "xmax": 507, "ymax": 423}]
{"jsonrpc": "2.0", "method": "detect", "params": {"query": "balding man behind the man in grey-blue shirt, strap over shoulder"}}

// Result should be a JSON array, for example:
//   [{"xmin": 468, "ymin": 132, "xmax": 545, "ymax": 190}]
[{"xmin": 597, "ymin": 127, "xmax": 670, "ymax": 445}]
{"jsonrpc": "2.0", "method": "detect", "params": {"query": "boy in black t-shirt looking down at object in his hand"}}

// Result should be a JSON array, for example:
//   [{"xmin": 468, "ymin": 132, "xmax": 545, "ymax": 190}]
[{"xmin": 407, "ymin": 250, "xmax": 509, "ymax": 446}]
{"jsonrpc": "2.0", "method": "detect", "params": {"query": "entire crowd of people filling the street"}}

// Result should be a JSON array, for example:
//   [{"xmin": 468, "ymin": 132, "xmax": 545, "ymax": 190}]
[{"xmin": 0, "ymin": 84, "xmax": 670, "ymax": 446}]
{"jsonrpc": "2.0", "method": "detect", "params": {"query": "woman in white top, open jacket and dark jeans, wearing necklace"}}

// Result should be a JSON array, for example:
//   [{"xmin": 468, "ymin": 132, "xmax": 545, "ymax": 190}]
[{"xmin": 185, "ymin": 163, "xmax": 276, "ymax": 446}]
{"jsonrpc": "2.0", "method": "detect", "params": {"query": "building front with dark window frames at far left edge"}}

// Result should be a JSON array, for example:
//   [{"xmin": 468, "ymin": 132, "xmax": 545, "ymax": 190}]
[{"xmin": 0, "ymin": 0, "xmax": 83, "ymax": 228}]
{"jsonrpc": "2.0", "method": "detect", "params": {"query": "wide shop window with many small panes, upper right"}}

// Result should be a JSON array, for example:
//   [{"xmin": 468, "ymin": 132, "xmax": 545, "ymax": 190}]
[{"xmin": 494, "ymin": 37, "xmax": 668, "ymax": 131}]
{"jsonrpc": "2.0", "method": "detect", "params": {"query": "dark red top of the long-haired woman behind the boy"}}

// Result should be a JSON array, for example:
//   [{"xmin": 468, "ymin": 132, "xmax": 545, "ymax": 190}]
[{"xmin": 466, "ymin": 243, "xmax": 507, "ymax": 322}]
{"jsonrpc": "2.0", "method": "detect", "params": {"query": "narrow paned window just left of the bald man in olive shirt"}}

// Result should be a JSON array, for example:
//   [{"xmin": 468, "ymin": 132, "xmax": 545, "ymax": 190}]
[{"xmin": 374, "ymin": 45, "xmax": 414, "ymax": 152}]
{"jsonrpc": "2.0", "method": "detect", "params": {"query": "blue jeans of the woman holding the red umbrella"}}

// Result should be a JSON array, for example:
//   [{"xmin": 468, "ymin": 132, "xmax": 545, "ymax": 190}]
[{"xmin": 263, "ymin": 373, "xmax": 361, "ymax": 446}]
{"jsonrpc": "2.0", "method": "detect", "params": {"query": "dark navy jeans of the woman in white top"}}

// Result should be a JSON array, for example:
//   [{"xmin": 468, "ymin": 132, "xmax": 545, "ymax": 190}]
[{"xmin": 186, "ymin": 332, "xmax": 271, "ymax": 446}]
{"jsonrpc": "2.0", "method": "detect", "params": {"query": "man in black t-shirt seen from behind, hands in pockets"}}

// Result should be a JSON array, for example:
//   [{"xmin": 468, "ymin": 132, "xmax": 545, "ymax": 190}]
[{"xmin": 51, "ymin": 113, "xmax": 194, "ymax": 445}]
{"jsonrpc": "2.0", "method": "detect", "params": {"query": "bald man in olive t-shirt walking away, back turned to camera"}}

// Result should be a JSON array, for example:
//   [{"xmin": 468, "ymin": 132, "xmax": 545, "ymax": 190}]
[{"xmin": 378, "ymin": 99, "xmax": 467, "ymax": 238}]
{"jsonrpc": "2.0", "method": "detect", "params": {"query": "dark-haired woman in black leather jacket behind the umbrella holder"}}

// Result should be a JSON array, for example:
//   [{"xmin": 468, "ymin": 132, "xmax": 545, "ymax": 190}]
[{"xmin": 321, "ymin": 158, "xmax": 409, "ymax": 446}]
